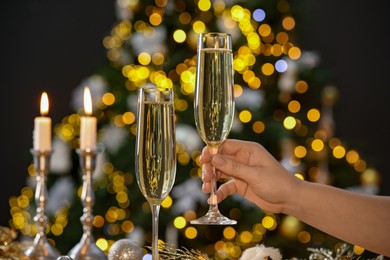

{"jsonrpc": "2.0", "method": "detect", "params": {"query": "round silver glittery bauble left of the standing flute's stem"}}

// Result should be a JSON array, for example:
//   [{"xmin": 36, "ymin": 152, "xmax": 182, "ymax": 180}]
[{"xmin": 107, "ymin": 238, "xmax": 143, "ymax": 260}]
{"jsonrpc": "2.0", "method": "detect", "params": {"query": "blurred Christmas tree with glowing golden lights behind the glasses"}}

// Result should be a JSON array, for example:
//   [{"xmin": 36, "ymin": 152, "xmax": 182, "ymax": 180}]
[{"xmin": 10, "ymin": 0, "xmax": 378, "ymax": 259}]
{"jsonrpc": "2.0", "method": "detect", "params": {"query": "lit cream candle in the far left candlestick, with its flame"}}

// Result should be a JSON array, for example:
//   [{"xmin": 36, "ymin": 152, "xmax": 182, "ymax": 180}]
[{"xmin": 33, "ymin": 92, "xmax": 51, "ymax": 151}]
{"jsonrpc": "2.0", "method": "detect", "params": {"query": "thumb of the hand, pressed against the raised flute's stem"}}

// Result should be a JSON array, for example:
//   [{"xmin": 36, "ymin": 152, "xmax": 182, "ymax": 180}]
[{"xmin": 212, "ymin": 154, "xmax": 256, "ymax": 183}]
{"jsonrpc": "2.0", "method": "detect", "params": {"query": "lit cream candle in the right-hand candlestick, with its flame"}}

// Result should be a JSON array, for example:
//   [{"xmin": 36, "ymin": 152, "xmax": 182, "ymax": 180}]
[{"xmin": 80, "ymin": 87, "xmax": 96, "ymax": 150}]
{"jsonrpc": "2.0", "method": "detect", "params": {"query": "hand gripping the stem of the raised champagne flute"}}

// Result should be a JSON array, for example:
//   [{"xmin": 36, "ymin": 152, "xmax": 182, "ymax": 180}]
[{"xmin": 200, "ymin": 139, "xmax": 301, "ymax": 213}]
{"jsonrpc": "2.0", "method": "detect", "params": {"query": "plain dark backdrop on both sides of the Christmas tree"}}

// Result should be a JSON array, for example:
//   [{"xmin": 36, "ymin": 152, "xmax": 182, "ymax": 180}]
[{"xmin": 0, "ymin": 0, "xmax": 390, "ymax": 226}]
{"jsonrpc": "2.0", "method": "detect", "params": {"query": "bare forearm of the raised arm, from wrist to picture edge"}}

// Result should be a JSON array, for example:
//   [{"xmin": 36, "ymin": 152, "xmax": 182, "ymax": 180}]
[{"xmin": 284, "ymin": 182, "xmax": 390, "ymax": 256}]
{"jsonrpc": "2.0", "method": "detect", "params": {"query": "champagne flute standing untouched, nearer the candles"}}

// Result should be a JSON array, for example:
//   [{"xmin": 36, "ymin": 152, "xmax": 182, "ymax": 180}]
[{"xmin": 135, "ymin": 88, "xmax": 176, "ymax": 260}]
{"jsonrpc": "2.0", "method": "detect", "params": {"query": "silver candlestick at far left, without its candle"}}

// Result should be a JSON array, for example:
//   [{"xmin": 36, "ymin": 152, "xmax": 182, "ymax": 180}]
[{"xmin": 25, "ymin": 149, "xmax": 60, "ymax": 260}]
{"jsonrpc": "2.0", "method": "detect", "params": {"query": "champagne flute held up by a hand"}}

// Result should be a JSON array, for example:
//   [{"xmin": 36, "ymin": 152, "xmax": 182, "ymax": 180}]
[{"xmin": 191, "ymin": 32, "xmax": 237, "ymax": 225}]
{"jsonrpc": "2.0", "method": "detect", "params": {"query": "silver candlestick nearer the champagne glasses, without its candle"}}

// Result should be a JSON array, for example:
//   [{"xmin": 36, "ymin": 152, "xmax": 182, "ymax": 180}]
[{"xmin": 68, "ymin": 146, "xmax": 107, "ymax": 260}]
